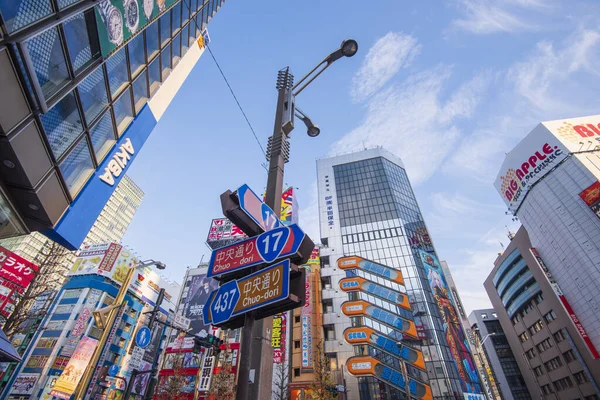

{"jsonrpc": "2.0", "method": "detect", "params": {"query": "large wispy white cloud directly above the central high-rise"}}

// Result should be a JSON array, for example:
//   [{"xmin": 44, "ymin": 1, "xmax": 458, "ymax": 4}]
[{"xmin": 331, "ymin": 66, "xmax": 487, "ymax": 184}]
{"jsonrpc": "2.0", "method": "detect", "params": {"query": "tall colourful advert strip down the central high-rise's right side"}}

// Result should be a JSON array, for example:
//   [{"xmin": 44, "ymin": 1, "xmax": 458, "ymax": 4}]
[{"xmin": 419, "ymin": 250, "xmax": 481, "ymax": 393}]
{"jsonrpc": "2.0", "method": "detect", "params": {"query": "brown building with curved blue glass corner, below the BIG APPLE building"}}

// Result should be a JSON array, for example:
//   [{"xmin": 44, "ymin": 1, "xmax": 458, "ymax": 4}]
[{"xmin": 479, "ymin": 227, "xmax": 600, "ymax": 399}]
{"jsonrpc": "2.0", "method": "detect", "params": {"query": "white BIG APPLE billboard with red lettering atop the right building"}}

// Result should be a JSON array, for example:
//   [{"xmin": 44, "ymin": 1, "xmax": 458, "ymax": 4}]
[{"xmin": 494, "ymin": 115, "xmax": 600, "ymax": 214}]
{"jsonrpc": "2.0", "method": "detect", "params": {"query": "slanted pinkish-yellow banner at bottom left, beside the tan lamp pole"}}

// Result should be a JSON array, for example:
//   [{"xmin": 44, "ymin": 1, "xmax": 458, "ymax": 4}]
[{"xmin": 50, "ymin": 336, "xmax": 98, "ymax": 400}]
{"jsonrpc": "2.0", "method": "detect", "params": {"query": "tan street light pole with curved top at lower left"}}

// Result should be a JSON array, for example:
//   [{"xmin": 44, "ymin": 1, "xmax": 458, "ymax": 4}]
[{"xmin": 75, "ymin": 260, "xmax": 165, "ymax": 399}]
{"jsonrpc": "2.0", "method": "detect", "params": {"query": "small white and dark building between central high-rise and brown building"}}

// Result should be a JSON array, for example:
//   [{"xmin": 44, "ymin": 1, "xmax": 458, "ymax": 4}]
[{"xmin": 469, "ymin": 308, "xmax": 531, "ymax": 400}]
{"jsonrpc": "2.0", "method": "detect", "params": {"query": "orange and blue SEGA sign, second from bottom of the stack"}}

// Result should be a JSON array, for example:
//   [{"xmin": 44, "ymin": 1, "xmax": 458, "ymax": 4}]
[{"xmin": 344, "ymin": 326, "xmax": 425, "ymax": 371}]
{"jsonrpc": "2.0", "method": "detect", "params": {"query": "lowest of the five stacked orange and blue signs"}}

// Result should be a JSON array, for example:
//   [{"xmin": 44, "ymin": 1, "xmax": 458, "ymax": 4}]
[{"xmin": 346, "ymin": 356, "xmax": 433, "ymax": 400}]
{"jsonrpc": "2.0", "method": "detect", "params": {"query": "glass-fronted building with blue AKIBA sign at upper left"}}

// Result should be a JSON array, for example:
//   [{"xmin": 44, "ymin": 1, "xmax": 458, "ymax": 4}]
[{"xmin": 0, "ymin": 0, "xmax": 224, "ymax": 250}]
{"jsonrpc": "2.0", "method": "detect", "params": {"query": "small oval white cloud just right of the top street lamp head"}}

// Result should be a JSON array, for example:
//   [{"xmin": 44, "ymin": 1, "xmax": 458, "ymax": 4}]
[{"xmin": 351, "ymin": 32, "xmax": 421, "ymax": 101}]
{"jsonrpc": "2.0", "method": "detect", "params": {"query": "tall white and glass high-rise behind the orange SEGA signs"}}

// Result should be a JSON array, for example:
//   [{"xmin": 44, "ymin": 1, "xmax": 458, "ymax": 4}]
[{"xmin": 317, "ymin": 148, "xmax": 483, "ymax": 399}]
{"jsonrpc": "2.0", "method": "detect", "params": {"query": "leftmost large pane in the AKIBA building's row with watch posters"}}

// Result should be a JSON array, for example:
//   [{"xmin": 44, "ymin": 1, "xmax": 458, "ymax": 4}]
[{"xmin": 25, "ymin": 28, "xmax": 69, "ymax": 99}]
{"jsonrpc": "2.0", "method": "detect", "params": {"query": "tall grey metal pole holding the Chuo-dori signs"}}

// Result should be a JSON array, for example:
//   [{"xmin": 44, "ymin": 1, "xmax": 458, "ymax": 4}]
[{"xmin": 235, "ymin": 68, "xmax": 292, "ymax": 400}]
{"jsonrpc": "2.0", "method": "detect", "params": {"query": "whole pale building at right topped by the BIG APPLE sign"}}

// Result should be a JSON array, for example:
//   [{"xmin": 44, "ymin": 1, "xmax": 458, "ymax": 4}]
[{"xmin": 495, "ymin": 115, "xmax": 600, "ymax": 349}]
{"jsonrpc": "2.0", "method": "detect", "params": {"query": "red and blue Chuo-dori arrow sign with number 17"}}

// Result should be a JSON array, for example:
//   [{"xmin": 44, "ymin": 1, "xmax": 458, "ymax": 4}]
[{"xmin": 207, "ymin": 224, "xmax": 314, "ymax": 277}]
